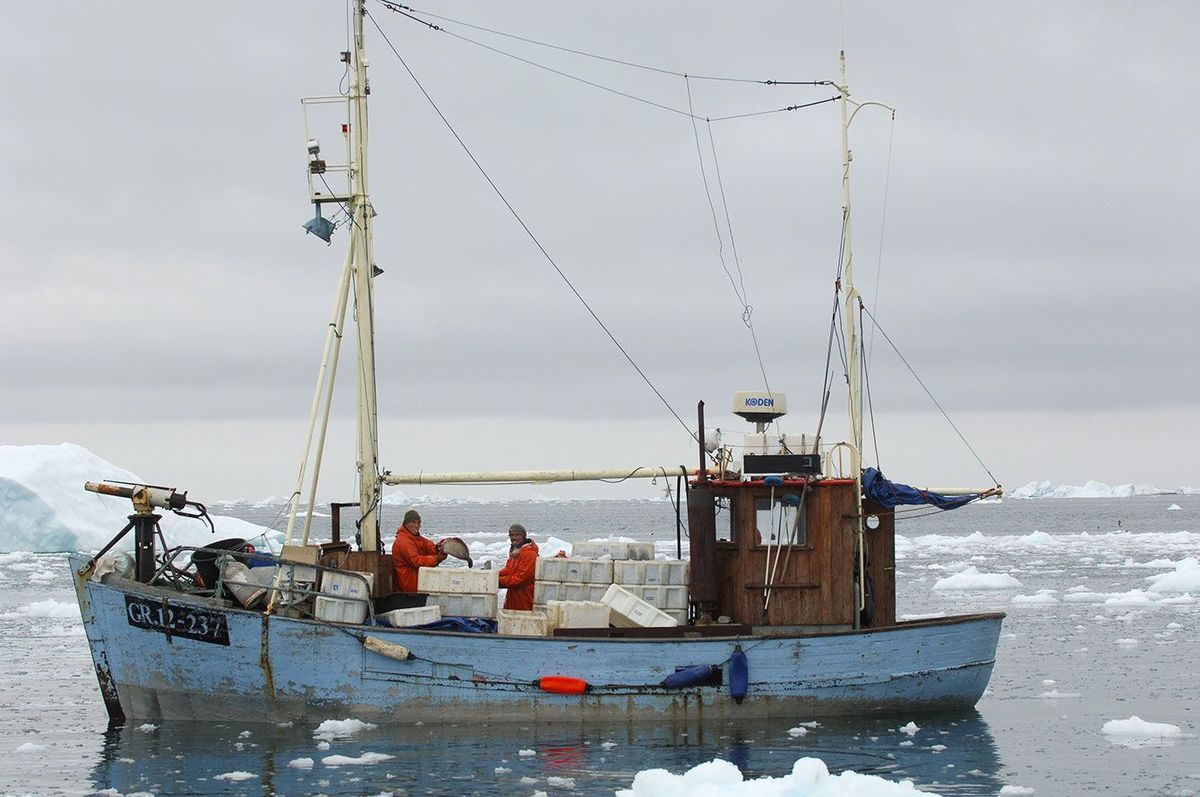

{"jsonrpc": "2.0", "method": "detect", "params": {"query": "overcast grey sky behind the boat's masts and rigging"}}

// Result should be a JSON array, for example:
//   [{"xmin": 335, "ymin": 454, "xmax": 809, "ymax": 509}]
[{"xmin": 0, "ymin": 0, "xmax": 1200, "ymax": 499}]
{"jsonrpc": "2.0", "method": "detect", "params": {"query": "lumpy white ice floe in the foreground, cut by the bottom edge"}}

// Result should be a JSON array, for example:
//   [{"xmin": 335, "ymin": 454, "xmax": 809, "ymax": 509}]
[{"xmin": 617, "ymin": 757, "xmax": 931, "ymax": 797}]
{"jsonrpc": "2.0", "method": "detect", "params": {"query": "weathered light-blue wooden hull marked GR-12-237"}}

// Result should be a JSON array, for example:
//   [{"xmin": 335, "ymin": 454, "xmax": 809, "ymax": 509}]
[{"xmin": 72, "ymin": 558, "xmax": 1003, "ymax": 723}]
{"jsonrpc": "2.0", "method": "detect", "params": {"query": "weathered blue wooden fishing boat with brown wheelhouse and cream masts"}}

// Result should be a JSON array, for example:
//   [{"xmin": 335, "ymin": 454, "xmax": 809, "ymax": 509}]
[{"xmin": 71, "ymin": 0, "xmax": 1003, "ymax": 723}]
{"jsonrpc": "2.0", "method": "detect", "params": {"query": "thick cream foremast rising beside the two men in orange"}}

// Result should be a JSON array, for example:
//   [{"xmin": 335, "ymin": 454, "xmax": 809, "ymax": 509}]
[{"xmin": 349, "ymin": 0, "xmax": 380, "ymax": 551}]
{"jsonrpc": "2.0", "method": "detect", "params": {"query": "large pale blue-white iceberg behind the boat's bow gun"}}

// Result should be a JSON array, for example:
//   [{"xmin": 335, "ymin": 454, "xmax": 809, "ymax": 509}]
[{"xmin": 0, "ymin": 443, "xmax": 274, "ymax": 553}]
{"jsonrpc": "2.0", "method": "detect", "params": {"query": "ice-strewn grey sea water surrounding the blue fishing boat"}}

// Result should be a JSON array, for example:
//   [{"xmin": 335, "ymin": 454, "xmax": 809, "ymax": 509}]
[{"xmin": 0, "ymin": 496, "xmax": 1200, "ymax": 796}]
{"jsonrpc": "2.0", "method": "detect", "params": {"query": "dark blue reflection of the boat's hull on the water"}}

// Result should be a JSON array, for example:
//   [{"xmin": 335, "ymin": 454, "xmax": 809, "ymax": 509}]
[{"xmin": 91, "ymin": 714, "xmax": 1002, "ymax": 796}]
